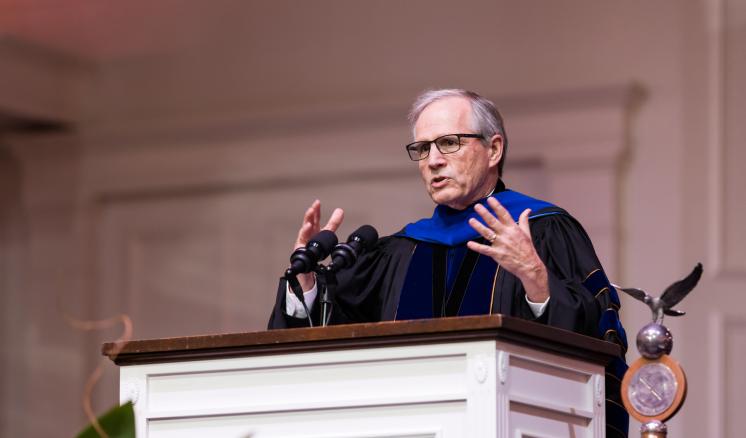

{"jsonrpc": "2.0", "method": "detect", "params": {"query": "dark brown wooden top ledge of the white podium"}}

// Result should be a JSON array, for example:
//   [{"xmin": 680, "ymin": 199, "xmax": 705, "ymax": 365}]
[{"xmin": 101, "ymin": 315, "xmax": 621, "ymax": 365}]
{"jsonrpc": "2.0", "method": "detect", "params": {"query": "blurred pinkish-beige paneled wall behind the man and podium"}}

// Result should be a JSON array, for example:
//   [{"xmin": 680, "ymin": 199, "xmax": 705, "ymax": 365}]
[{"xmin": 0, "ymin": 0, "xmax": 746, "ymax": 437}]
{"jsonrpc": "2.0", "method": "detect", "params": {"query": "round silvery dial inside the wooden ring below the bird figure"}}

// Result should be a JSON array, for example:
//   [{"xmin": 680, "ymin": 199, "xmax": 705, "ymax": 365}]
[{"xmin": 627, "ymin": 362, "xmax": 678, "ymax": 417}]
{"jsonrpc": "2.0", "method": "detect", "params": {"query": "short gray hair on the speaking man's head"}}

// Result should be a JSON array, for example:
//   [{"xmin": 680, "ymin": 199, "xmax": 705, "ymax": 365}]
[{"xmin": 408, "ymin": 88, "xmax": 508, "ymax": 176}]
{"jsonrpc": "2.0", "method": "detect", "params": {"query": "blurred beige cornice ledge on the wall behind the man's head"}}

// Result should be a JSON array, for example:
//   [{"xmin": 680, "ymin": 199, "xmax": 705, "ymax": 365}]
[{"xmin": 79, "ymin": 83, "xmax": 641, "ymax": 154}]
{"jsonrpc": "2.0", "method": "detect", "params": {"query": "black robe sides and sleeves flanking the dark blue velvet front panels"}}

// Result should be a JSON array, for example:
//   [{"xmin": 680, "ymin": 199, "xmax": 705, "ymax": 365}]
[{"xmin": 269, "ymin": 210, "xmax": 608, "ymax": 337}]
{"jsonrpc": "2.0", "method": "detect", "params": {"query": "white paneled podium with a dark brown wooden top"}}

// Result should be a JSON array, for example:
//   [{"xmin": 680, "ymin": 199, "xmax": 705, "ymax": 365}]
[{"xmin": 102, "ymin": 315, "xmax": 620, "ymax": 438}]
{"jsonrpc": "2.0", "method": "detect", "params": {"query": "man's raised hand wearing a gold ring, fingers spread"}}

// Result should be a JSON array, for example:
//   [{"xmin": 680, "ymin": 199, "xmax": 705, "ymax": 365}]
[{"xmin": 466, "ymin": 198, "xmax": 549, "ymax": 303}]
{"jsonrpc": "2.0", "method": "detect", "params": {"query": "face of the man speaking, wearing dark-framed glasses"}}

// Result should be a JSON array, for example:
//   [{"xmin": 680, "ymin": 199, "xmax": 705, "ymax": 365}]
[{"xmin": 414, "ymin": 97, "xmax": 502, "ymax": 210}]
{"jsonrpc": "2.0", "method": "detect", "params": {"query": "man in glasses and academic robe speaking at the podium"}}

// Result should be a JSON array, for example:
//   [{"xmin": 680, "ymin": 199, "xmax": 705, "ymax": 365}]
[{"xmin": 269, "ymin": 89, "xmax": 627, "ymax": 436}]
